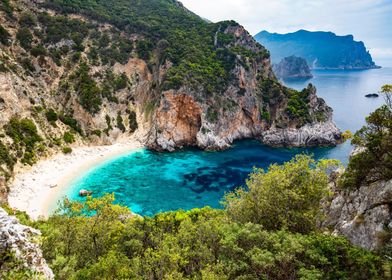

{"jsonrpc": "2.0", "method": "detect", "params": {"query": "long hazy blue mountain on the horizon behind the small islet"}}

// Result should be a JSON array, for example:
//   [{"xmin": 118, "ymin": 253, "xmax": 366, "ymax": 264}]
[{"xmin": 255, "ymin": 30, "xmax": 378, "ymax": 69}]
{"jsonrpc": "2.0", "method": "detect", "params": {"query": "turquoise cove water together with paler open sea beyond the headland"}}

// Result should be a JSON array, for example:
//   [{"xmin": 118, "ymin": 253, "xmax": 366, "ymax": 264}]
[{"xmin": 59, "ymin": 68, "xmax": 392, "ymax": 215}]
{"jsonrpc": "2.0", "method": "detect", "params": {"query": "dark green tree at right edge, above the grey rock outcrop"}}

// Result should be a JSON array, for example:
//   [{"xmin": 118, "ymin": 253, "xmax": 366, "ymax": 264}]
[{"xmin": 341, "ymin": 86, "xmax": 392, "ymax": 188}]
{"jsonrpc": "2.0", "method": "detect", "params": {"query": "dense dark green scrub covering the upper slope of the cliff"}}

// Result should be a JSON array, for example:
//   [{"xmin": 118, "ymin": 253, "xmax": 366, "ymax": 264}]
[{"xmin": 44, "ymin": 0, "xmax": 269, "ymax": 93}]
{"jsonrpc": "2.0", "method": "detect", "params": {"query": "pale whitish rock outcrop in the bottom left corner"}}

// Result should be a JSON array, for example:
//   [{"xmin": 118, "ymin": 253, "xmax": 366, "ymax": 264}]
[{"xmin": 0, "ymin": 208, "xmax": 54, "ymax": 279}]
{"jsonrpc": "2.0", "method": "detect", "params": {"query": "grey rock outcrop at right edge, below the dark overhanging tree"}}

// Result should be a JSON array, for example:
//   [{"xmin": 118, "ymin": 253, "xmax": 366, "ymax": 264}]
[{"xmin": 324, "ymin": 180, "xmax": 392, "ymax": 250}]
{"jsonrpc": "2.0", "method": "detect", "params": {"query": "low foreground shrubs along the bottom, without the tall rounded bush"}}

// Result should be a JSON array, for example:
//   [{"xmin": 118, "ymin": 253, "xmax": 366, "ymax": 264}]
[{"xmin": 38, "ymin": 192, "xmax": 384, "ymax": 280}]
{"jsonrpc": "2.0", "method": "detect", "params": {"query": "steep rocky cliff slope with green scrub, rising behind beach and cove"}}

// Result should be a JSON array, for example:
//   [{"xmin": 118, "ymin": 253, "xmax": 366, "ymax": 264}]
[{"xmin": 0, "ymin": 0, "xmax": 340, "ymax": 191}]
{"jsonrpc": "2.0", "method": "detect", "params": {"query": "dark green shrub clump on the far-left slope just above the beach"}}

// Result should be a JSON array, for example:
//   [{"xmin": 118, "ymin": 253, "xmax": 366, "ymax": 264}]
[{"xmin": 4, "ymin": 117, "xmax": 42, "ymax": 165}]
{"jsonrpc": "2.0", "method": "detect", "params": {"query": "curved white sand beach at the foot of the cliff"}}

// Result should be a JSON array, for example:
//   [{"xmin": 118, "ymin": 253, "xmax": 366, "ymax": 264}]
[{"xmin": 8, "ymin": 141, "xmax": 142, "ymax": 219}]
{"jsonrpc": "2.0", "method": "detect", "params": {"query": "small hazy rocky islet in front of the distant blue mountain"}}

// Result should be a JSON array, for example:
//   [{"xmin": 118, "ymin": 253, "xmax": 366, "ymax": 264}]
[{"xmin": 272, "ymin": 55, "xmax": 313, "ymax": 79}]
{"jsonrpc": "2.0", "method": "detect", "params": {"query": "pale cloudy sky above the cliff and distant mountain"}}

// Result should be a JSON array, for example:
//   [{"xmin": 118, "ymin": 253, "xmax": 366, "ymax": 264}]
[{"xmin": 180, "ymin": 0, "xmax": 392, "ymax": 66}]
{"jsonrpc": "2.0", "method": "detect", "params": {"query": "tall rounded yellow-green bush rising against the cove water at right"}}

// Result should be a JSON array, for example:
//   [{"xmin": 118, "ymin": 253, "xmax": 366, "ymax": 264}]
[{"xmin": 225, "ymin": 155, "xmax": 337, "ymax": 233}]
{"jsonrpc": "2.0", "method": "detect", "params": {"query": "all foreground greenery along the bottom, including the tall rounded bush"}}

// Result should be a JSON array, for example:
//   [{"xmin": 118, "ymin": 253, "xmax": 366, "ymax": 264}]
[{"xmin": 29, "ymin": 156, "xmax": 387, "ymax": 279}]
